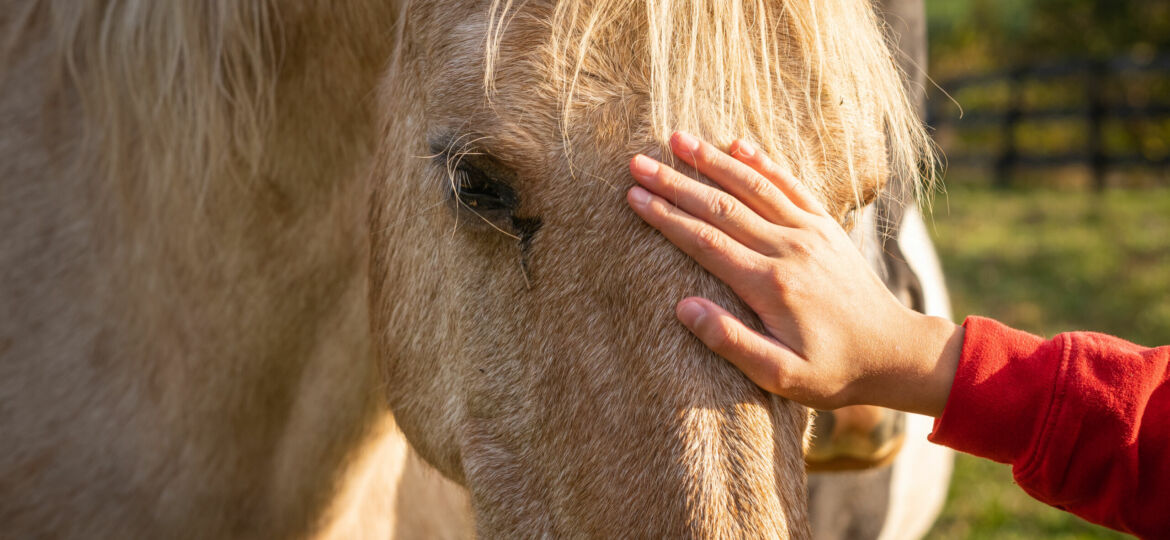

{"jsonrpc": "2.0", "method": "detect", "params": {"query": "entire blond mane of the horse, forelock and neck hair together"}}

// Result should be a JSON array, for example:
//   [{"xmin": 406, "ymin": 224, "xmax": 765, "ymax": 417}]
[{"xmin": 9, "ymin": 0, "xmax": 936, "ymax": 215}]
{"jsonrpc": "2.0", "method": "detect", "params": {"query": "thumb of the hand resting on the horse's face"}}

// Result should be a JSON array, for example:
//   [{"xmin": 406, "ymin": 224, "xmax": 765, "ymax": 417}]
[{"xmin": 675, "ymin": 297, "xmax": 805, "ymax": 397}]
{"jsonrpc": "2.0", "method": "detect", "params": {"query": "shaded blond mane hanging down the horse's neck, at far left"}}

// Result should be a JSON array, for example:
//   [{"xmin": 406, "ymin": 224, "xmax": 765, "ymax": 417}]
[{"xmin": 0, "ymin": 0, "xmax": 280, "ymax": 206}]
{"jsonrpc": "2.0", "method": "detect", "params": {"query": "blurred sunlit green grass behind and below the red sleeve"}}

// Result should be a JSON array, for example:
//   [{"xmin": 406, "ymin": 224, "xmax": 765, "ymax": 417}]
[{"xmin": 928, "ymin": 187, "xmax": 1170, "ymax": 539}]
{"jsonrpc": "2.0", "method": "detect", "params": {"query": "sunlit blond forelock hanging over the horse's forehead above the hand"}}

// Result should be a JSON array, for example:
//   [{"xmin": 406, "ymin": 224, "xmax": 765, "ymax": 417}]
[{"xmin": 484, "ymin": 0, "xmax": 936, "ymax": 210}]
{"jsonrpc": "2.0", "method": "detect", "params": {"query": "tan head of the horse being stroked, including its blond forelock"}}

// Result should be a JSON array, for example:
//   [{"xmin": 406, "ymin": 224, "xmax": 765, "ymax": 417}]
[{"xmin": 371, "ymin": 2, "xmax": 931, "ymax": 538}]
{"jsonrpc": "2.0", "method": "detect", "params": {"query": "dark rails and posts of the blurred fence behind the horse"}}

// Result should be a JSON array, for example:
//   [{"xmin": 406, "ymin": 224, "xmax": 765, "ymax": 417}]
[{"xmin": 928, "ymin": 54, "xmax": 1170, "ymax": 189}]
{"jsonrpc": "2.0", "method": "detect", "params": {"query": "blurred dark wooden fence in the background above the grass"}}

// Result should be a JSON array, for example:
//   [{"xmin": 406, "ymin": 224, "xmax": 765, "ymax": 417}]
[{"xmin": 927, "ymin": 54, "xmax": 1170, "ymax": 189}]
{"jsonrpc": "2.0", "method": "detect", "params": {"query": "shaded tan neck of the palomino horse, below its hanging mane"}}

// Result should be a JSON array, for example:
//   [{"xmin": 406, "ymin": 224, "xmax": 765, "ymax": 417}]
[{"xmin": 0, "ymin": 2, "xmax": 411, "ymax": 536}]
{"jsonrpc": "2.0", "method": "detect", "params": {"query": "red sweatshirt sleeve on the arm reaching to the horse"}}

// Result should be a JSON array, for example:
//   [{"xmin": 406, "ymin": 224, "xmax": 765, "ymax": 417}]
[{"xmin": 930, "ymin": 317, "xmax": 1170, "ymax": 538}]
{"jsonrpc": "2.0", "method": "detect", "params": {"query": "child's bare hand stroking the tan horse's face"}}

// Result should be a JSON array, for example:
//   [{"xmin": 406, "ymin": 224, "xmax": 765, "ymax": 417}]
[{"xmin": 627, "ymin": 133, "xmax": 963, "ymax": 416}]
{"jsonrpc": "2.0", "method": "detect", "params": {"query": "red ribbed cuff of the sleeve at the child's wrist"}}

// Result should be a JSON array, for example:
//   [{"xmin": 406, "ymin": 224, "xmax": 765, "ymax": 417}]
[{"xmin": 930, "ymin": 317, "xmax": 1064, "ymax": 463}]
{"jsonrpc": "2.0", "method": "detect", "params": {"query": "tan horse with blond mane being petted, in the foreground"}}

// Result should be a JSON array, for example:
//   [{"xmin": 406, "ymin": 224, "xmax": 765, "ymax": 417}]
[{"xmin": 0, "ymin": 0, "xmax": 931, "ymax": 539}]
